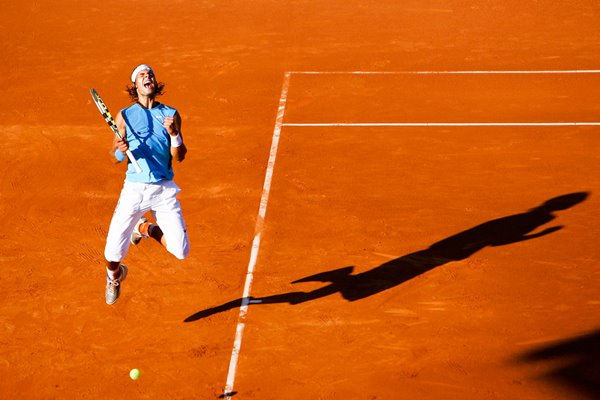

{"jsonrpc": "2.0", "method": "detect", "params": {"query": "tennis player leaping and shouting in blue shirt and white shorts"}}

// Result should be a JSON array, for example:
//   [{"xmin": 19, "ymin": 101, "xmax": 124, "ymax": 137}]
[{"xmin": 104, "ymin": 64, "xmax": 190, "ymax": 304}]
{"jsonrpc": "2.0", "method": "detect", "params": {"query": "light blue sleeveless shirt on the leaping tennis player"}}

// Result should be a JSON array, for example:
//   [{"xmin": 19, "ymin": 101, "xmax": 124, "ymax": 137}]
[{"xmin": 121, "ymin": 103, "xmax": 177, "ymax": 183}]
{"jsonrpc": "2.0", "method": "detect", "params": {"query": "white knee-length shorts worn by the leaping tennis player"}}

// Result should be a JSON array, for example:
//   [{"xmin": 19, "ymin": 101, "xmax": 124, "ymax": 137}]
[{"xmin": 104, "ymin": 181, "xmax": 190, "ymax": 262}]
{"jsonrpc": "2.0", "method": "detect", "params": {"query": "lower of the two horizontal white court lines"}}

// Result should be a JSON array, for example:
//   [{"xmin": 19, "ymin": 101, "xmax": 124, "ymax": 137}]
[{"xmin": 283, "ymin": 122, "xmax": 600, "ymax": 127}]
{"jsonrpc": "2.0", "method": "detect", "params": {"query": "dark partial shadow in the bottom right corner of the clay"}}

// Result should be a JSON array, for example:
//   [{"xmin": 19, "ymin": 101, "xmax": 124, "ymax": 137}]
[{"xmin": 517, "ymin": 330, "xmax": 600, "ymax": 399}]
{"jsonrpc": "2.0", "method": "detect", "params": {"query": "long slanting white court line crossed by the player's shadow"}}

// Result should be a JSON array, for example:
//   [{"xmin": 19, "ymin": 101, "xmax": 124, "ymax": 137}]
[{"xmin": 223, "ymin": 72, "xmax": 291, "ymax": 399}]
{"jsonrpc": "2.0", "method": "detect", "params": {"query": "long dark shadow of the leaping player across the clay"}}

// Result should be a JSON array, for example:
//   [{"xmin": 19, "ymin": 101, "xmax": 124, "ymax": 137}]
[{"xmin": 184, "ymin": 192, "xmax": 589, "ymax": 322}]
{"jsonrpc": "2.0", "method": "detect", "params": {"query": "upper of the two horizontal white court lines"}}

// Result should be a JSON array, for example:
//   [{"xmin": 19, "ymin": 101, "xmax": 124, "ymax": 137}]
[{"xmin": 292, "ymin": 69, "xmax": 600, "ymax": 75}]
